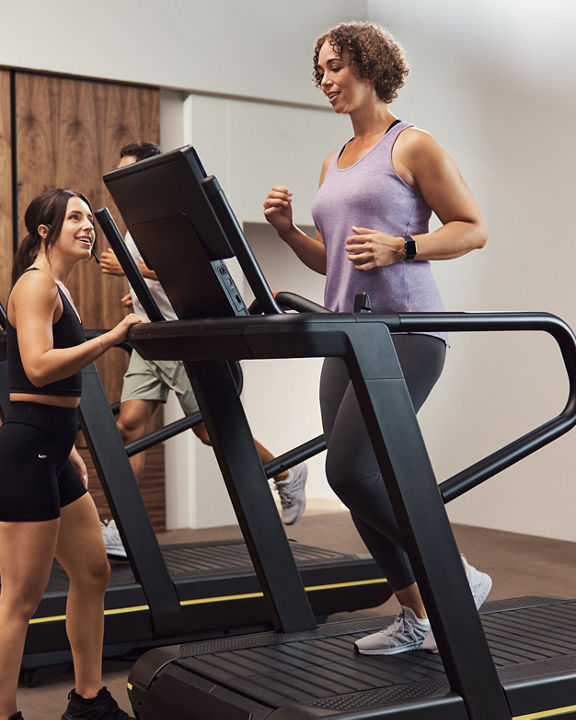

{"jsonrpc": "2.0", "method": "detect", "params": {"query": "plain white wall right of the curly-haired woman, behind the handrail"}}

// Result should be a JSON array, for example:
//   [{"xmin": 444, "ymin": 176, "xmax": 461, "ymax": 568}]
[{"xmin": 368, "ymin": 0, "xmax": 576, "ymax": 540}]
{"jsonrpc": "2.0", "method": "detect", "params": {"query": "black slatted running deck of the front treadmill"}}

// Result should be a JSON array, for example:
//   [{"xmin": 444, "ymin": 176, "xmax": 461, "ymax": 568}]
[{"xmin": 131, "ymin": 597, "xmax": 576, "ymax": 720}]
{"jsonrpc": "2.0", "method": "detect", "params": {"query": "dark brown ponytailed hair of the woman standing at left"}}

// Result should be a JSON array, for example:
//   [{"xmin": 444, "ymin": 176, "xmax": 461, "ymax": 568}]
[{"xmin": 12, "ymin": 188, "xmax": 90, "ymax": 285}]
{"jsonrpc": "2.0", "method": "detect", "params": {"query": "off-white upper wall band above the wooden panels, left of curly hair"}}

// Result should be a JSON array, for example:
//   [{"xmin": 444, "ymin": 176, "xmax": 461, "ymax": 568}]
[{"xmin": 0, "ymin": 0, "xmax": 366, "ymax": 104}]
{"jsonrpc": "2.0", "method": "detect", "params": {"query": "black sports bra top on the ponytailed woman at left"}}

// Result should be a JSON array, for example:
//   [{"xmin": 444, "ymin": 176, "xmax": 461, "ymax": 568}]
[{"xmin": 6, "ymin": 268, "xmax": 86, "ymax": 397}]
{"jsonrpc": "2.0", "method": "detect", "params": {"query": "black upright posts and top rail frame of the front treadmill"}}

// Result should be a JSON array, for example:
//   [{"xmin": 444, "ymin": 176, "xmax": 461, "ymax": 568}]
[{"xmin": 130, "ymin": 313, "xmax": 576, "ymax": 720}]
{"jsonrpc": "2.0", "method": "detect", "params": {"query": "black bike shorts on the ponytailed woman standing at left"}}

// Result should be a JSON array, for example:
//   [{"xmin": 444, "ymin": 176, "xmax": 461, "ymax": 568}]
[{"xmin": 0, "ymin": 402, "xmax": 86, "ymax": 522}]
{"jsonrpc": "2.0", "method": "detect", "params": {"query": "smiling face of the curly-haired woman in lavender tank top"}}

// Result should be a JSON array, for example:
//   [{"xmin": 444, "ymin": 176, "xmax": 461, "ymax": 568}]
[{"xmin": 316, "ymin": 40, "xmax": 376, "ymax": 114}]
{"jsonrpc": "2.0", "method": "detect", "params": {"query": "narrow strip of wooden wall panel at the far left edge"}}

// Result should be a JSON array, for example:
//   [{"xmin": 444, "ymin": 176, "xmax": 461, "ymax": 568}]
[{"xmin": 0, "ymin": 70, "xmax": 13, "ymax": 307}]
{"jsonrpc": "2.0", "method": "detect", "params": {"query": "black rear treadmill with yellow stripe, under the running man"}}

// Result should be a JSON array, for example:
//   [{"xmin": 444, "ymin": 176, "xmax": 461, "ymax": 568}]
[{"xmin": 0, "ymin": 238, "xmax": 391, "ymax": 686}]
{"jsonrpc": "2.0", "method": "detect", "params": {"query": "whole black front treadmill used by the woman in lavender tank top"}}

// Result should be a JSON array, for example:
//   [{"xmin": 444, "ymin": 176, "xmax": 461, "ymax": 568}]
[{"xmin": 105, "ymin": 147, "xmax": 576, "ymax": 720}]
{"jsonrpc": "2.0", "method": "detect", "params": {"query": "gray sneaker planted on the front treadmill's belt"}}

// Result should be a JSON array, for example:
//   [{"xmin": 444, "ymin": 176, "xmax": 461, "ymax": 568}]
[{"xmin": 354, "ymin": 606, "xmax": 430, "ymax": 655}]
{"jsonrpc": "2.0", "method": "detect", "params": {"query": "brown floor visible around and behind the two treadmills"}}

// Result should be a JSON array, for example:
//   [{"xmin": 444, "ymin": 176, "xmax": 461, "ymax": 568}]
[{"xmin": 15, "ymin": 512, "xmax": 576, "ymax": 720}]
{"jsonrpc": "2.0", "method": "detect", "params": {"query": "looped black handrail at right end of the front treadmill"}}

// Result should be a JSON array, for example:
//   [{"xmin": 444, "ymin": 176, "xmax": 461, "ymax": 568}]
[{"xmin": 397, "ymin": 312, "xmax": 576, "ymax": 503}]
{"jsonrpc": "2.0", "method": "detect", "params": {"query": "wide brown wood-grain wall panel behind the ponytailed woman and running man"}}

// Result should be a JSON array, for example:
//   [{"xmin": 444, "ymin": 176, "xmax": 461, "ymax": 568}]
[{"xmin": 15, "ymin": 72, "xmax": 165, "ymax": 529}]
